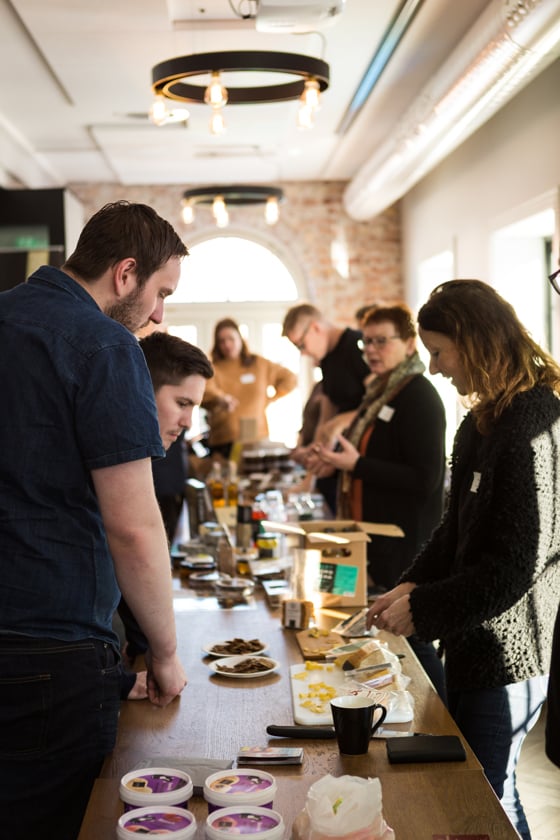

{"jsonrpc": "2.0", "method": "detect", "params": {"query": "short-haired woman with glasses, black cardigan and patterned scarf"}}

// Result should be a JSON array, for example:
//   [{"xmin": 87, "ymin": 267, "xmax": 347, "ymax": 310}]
[{"xmin": 311, "ymin": 303, "xmax": 445, "ymax": 700}]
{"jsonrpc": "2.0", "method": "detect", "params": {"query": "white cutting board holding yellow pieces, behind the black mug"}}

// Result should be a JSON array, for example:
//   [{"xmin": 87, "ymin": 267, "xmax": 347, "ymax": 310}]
[{"xmin": 290, "ymin": 662, "xmax": 414, "ymax": 726}]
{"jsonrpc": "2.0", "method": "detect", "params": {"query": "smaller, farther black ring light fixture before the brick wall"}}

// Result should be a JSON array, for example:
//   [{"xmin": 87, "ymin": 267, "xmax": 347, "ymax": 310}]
[{"xmin": 181, "ymin": 184, "xmax": 284, "ymax": 227}]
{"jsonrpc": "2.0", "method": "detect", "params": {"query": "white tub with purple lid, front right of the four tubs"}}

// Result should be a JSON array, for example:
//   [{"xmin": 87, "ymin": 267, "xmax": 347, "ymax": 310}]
[{"xmin": 206, "ymin": 805, "xmax": 286, "ymax": 840}]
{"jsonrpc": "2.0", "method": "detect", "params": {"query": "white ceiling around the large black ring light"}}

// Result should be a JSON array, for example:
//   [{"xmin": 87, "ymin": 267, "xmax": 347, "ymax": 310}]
[{"xmin": 0, "ymin": 0, "xmax": 557, "ymax": 217}]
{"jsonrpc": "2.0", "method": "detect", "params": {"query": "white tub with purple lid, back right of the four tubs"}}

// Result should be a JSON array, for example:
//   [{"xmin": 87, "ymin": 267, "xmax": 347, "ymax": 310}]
[{"xmin": 204, "ymin": 767, "xmax": 276, "ymax": 814}]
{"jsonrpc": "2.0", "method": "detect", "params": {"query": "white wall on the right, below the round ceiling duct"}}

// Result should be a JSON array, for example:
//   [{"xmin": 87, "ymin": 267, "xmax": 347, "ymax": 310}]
[{"xmin": 402, "ymin": 61, "xmax": 560, "ymax": 286}]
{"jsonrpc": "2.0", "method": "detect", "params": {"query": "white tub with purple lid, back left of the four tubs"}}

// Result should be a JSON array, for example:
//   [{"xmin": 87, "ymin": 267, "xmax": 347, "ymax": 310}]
[{"xmin": 119, "ymin": 767, "xmax": 193, "ymax": 812}]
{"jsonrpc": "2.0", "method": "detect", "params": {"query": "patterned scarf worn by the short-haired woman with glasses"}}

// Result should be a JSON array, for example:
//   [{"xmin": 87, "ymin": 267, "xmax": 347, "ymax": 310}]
[{"xmin": 337, "ymin": 350, "xmax": 426, "ymax": 519}]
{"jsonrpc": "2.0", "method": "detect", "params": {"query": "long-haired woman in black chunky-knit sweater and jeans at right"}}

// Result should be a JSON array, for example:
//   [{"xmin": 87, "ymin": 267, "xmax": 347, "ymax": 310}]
[{"xmin": 368, "ymin": 280, "xmax": 560, "ymax": 840}]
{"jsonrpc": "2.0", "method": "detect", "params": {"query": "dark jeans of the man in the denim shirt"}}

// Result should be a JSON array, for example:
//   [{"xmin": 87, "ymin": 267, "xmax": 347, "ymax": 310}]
[{"xmin": 0, "ymin": 636, "xmax": 120, "ymax": 840}]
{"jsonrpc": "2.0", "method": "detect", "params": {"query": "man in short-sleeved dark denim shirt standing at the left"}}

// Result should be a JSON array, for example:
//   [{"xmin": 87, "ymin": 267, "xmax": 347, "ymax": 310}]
[{"xmin": 0, "ymin": 202, "xmax": 187, "ymax": 840}]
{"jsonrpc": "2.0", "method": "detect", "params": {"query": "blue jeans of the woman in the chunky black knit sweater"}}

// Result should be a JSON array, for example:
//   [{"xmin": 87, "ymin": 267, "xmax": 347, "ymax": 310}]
[{"xmin": 449, "ymin": 677, "xmax": 548, "ymax": 840}]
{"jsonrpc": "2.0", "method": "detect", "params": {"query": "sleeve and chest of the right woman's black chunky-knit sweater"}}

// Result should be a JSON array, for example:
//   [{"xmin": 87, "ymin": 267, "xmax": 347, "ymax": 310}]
[{"xmin": 403, "ymin": 389, "xmax": 560, "ymax": 639}]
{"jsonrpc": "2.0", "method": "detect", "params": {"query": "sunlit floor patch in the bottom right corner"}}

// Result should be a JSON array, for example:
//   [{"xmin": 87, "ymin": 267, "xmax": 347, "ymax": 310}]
[{"xmin": 517, "ymin": 710, "xmax": 560, "ymax": 840}]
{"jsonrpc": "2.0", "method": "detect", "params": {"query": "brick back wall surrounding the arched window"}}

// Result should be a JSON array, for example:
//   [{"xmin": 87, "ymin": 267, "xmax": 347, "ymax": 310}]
[{"xmin": 69, "ymin": 181, "xmax": 403, "ymax": 325}]
